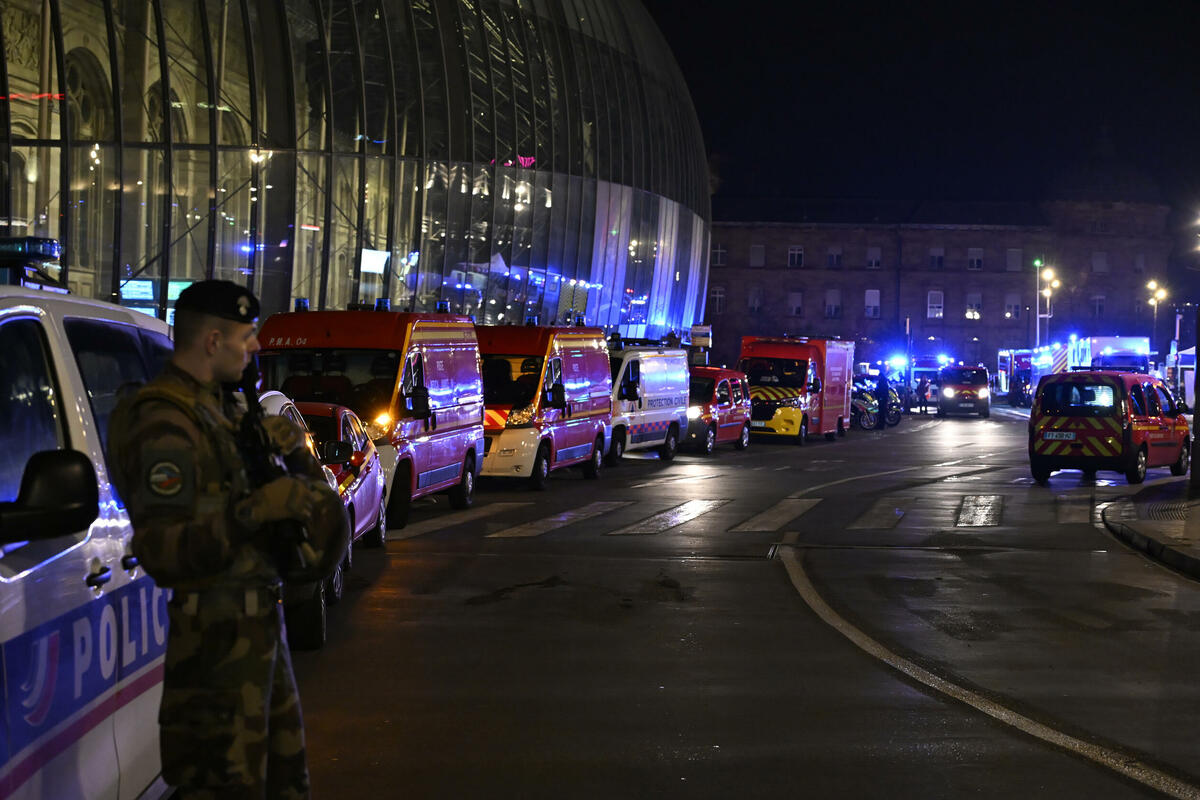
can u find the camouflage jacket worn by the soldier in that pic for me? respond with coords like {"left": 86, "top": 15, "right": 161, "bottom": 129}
{"left": 108, "top": 363, "right": 324, "bottom": 590}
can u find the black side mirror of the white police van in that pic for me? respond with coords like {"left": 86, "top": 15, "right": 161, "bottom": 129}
{"left": 0, "top": 450, "right": 100, "bottom": 545}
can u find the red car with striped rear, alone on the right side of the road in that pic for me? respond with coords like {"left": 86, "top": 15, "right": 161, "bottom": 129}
{"left": 1030, "top": 371, "right": 1192, "bottom": 483}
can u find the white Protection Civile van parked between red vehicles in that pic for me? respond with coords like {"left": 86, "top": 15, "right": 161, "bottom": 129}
{"left": 608, "top": 342, "right": 690, "bottom": 463}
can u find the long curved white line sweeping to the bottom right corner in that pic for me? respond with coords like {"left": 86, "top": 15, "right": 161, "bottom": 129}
{"left": 780, "top": 533, "right": 1200, "bottom": 800}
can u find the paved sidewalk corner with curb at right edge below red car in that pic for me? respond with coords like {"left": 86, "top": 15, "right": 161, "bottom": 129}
{"left": 1102, "top": 479, "right": 1200, "bottom": 581}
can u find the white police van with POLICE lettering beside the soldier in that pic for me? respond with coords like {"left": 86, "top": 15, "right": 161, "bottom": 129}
{"left": 0, "top": 287, "right": 172, "bottom": 800}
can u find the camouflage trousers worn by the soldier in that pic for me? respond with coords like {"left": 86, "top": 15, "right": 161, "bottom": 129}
{"left": 158, "top": 590, "right": 308, "bottom": 800}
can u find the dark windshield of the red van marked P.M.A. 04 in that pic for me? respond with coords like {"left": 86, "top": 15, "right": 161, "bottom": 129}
{"left": 258, "top": 349, "right": 402, "bottom": 420}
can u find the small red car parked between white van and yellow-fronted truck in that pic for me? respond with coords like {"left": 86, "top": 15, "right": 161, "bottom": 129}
{"left": 688, "top": 366, "right": 750, "bottom": 455}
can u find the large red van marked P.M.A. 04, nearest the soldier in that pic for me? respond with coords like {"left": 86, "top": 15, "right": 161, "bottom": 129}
{"left": 258, "top": 311, "right": 484, "bottom": 528}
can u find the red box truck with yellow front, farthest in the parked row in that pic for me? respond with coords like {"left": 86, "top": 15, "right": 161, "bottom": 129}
{"left": 738, "top": 336, "right": 854, "bottom": 445}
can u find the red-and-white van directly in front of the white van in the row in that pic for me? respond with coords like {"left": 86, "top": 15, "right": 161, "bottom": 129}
{"left": 475, "top": 325, "right": 612, "bottom": 489}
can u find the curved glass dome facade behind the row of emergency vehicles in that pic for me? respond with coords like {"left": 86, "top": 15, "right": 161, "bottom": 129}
{"left": 0, "top": 0, "right": 710, "bottom": 336}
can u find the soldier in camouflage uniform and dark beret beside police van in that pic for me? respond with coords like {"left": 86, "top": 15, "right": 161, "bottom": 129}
{"left": 109, "top": 281, "right": 346, "bottom": 798}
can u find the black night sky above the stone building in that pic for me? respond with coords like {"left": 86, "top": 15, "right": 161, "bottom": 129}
{"left": 644, "top": 0, "right": 1200, "bottom": 266}
